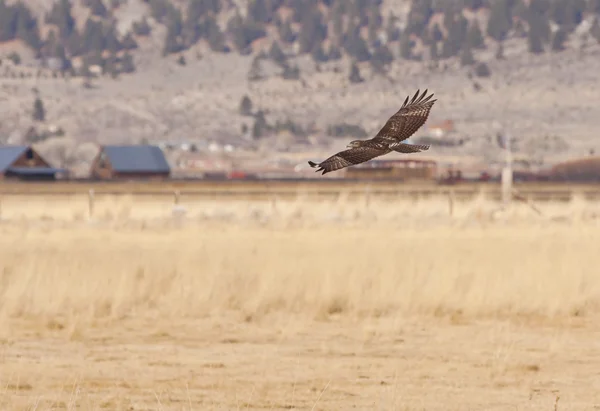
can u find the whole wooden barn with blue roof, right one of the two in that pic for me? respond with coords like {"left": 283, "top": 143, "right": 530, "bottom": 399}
{"left": 90, "top": 145, "right": 171, "bottom": 180}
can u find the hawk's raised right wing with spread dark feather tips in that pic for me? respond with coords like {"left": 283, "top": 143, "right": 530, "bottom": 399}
{"left": 373, "top": 90, "right": 437, "bottom": 148}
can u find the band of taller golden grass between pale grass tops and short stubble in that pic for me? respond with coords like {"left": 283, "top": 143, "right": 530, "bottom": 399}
{"left": 0, "top": 217, "right": 600, "bottom": 322}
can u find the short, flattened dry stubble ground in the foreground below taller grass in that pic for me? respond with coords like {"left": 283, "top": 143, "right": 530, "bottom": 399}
{"left": 0, "top": 316, "right": 600, "bottom": 410}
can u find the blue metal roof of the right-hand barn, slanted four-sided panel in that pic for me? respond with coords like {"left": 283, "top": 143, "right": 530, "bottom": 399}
{"left": 103, "top": 145, "right": 171, "bottom": 173}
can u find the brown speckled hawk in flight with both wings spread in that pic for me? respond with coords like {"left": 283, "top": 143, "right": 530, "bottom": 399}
{"left": 308, "top": 90, "right": 437, "bottom": 174}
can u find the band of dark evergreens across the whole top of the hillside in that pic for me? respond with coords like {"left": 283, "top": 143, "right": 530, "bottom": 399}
{"left": 0, "top": 0, "right": 600, "bottom": 82}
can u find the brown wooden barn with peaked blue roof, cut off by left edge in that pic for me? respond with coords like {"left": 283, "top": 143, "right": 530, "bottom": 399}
{"left": 0, "top": 146, "right": 67, "bottom": 181}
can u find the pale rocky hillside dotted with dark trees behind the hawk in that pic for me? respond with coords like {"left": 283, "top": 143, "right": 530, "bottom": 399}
{"left": 0, "top": 0, "right": 600, "bottom": 173}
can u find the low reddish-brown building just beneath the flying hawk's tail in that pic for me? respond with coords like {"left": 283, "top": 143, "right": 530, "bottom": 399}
{"left": 344, "top": 159, "right": 437, "bottom": 180}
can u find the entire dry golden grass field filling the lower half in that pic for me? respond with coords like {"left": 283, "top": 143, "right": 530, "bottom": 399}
{"left": 0, "top": 188, "right": 600, "bottom": 411}
